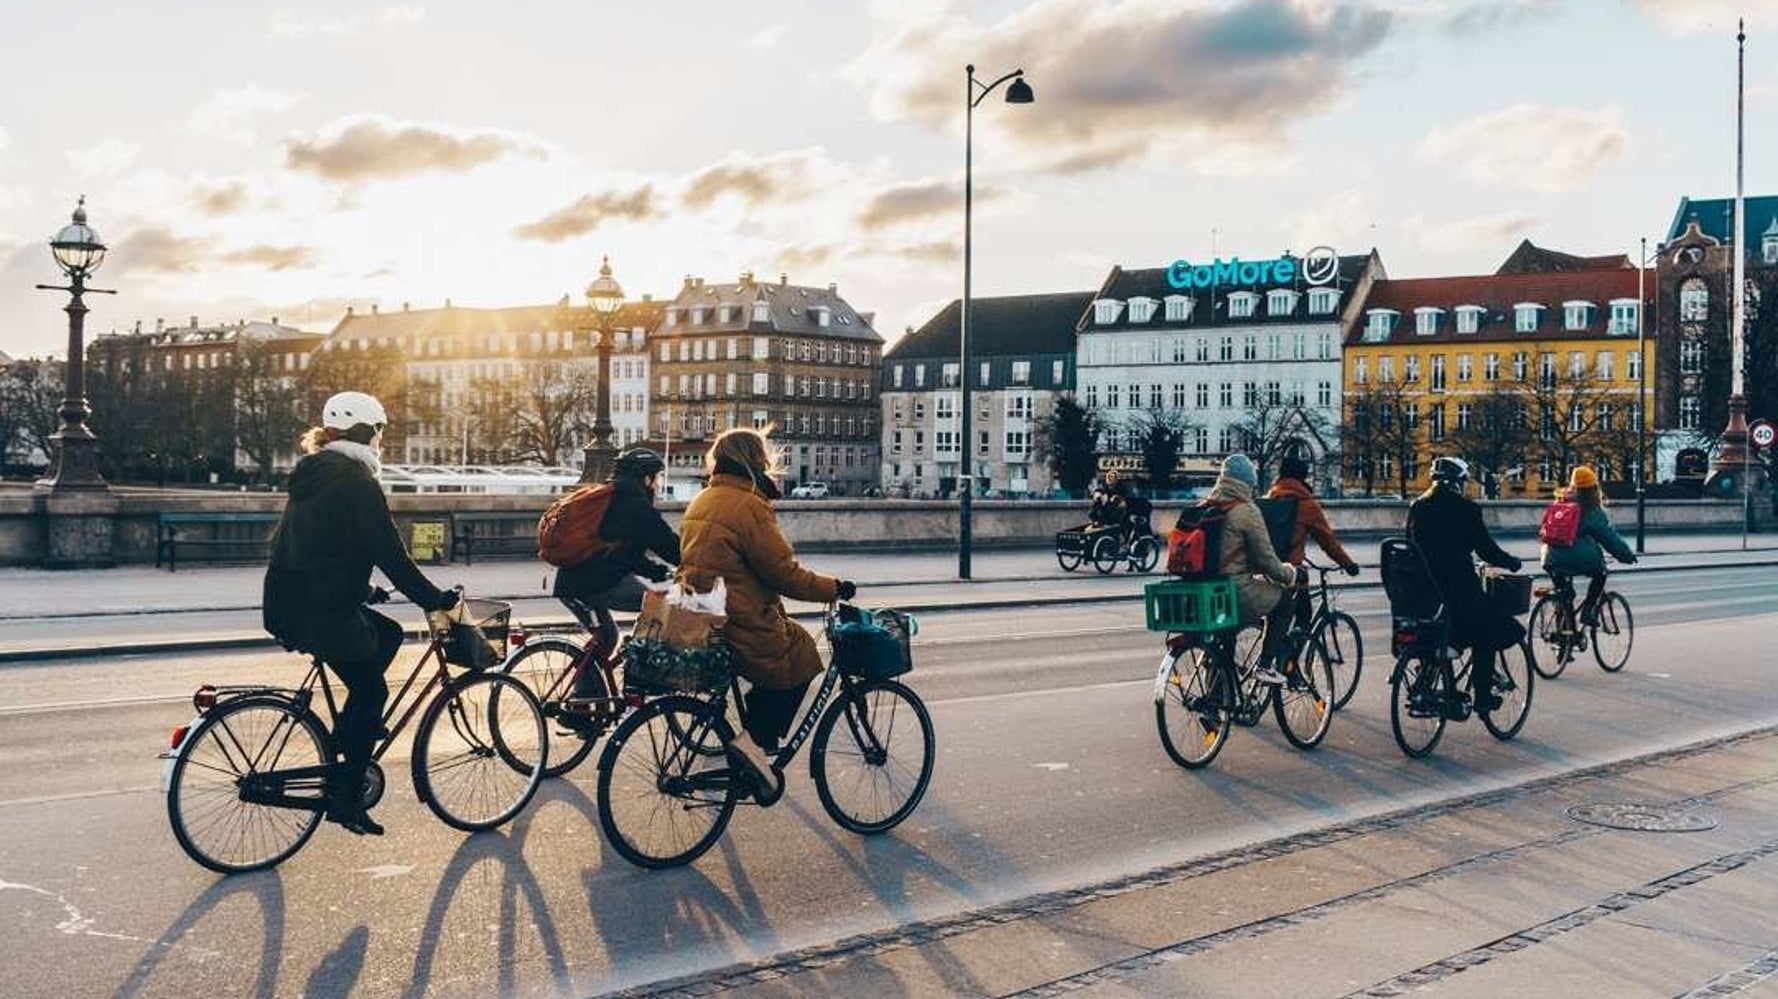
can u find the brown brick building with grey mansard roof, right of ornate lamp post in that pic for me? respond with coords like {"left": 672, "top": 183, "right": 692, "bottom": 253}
{"left": 649, "top": 272, "right": 882, "bottom": 496}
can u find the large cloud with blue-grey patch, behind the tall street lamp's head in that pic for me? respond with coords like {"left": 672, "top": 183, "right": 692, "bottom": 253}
{"left": 845, "top": 0, "right": 1396, "bottom": 172}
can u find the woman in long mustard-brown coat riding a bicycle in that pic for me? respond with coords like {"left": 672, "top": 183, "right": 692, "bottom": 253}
{"left": 679, "top": 428, "right": 857, "bottom": 802}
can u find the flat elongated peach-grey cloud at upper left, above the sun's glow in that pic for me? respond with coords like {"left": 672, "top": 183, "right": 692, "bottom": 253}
{"left": 284, "top": 117, "right": 544, "bottom": 183}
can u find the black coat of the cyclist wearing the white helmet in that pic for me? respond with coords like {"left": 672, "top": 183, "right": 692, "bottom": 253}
{"left": 261, "top": 450, "right": 450, "bottom": 663}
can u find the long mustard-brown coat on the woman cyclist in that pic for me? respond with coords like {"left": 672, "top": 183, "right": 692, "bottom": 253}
{"left": 679, "top": 473, "right": 839, "bottom": 690}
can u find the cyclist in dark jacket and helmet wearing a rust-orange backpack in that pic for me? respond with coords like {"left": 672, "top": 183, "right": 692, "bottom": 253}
{"left": 537, "top": 448, "right": 679, "bottom": 731}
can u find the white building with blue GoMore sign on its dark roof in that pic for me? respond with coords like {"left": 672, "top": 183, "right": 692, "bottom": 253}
{"left": 1076, "top": 251, "right": 1385, "bottom": 487}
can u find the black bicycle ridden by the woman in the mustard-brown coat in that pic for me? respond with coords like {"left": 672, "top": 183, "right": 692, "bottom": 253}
{"left": 599, "top": 604, "right": 935, "bottom": 867}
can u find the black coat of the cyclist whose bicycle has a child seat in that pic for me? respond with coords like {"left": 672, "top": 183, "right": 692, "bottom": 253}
{"left": 1408, "top": 485, "right": 1526, "bottom": 651}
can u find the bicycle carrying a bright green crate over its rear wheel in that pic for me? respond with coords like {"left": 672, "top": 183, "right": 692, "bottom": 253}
{"left": 1150, "top": 572, "right": 1334, "bottom": 770}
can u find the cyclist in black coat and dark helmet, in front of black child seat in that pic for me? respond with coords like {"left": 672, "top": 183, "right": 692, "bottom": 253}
{"left": 1408, "top": 457, "right": 1526, "bottom": 718}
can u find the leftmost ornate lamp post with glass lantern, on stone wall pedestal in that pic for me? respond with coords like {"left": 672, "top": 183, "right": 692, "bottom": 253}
{"left": 37, "top": 197, "right": 116, "bottom": 491}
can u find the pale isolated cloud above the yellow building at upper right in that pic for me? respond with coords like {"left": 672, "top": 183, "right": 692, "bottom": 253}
{"left": 1421, "top": 103, "right": 1630, "bottom": 194}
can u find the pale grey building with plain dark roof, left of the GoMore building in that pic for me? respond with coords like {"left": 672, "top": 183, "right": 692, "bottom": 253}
{"left": 882, "top": 292, "right": 1093, "bottom": 496}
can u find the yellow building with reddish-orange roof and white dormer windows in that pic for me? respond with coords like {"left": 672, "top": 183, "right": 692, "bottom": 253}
{"left": 1341, "top": 252, "right": 1655, "bottom": 498}
